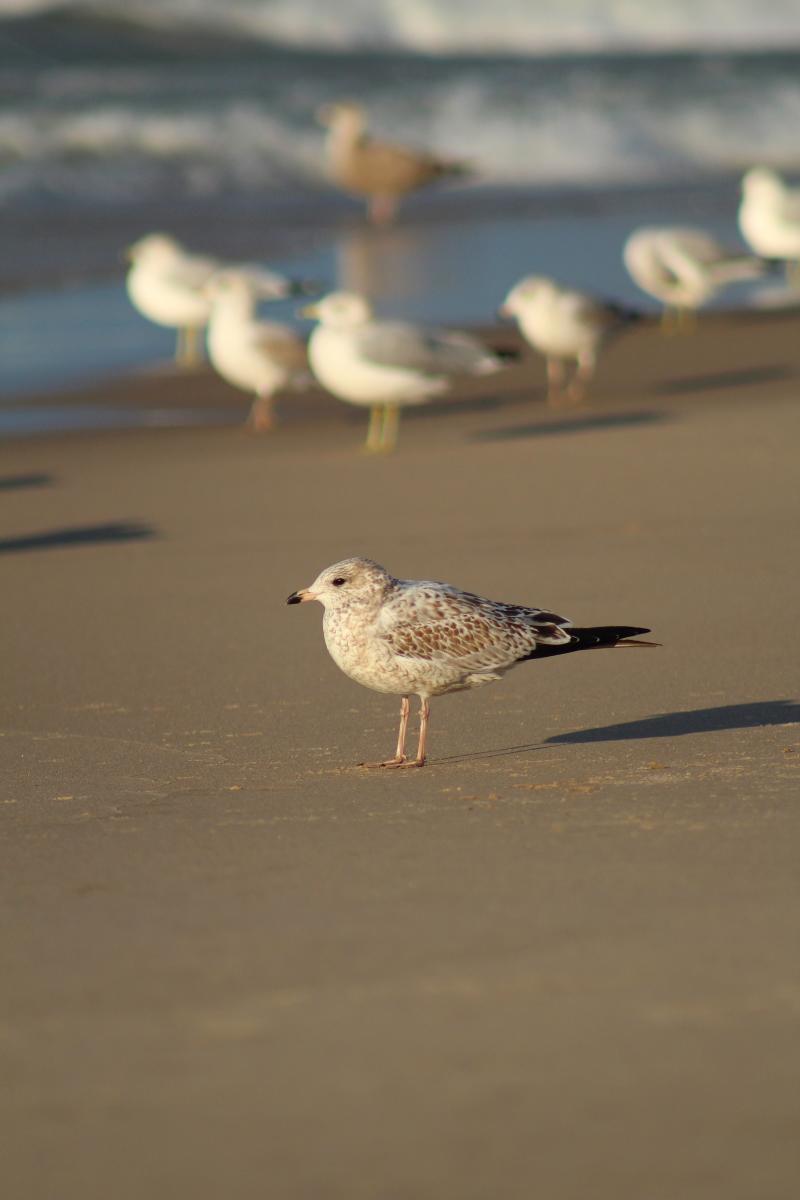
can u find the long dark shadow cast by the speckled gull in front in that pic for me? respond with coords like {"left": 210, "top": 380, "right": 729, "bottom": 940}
{"left": 432, "top": 700, "right": 800, "bottom": 766}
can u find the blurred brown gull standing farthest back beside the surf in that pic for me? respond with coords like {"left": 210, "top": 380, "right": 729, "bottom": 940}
{"left": 317, "top": 101, "right": 470, "bottom": 224}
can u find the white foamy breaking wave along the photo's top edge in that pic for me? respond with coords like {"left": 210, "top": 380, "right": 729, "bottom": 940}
{"left": 0, "top": 0, "right": 800, "bottom": 56}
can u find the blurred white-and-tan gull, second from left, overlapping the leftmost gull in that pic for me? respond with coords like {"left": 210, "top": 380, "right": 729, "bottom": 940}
{"left": 204, "top": 268, "right": 307, "bottom": 433}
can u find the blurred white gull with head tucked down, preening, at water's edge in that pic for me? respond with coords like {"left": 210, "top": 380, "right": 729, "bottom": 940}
{"left": 622, "top": 226, "right": 768, "bottom": 331}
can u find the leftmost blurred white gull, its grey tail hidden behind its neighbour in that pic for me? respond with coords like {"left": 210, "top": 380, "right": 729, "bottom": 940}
{"left": 125, "top": 233, "right": 224, "bottom": 366}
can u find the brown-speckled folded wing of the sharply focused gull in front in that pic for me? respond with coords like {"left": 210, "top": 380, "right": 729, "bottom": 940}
{"left": 381, "top": 586, "right": 570, "bottom": 671}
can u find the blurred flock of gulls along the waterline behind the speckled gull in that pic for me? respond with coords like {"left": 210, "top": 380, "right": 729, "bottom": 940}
{"left": 127, "top": 102, "right": 800, "bottom": 452}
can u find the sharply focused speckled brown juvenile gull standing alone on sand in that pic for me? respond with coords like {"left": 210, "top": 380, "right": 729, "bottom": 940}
{"left": 287, "top": 558, "right": 657, "bottom": 767}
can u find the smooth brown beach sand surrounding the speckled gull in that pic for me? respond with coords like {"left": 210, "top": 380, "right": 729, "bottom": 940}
{"left": 0, "top": 317, "right": 800, "bottom": 1200}
